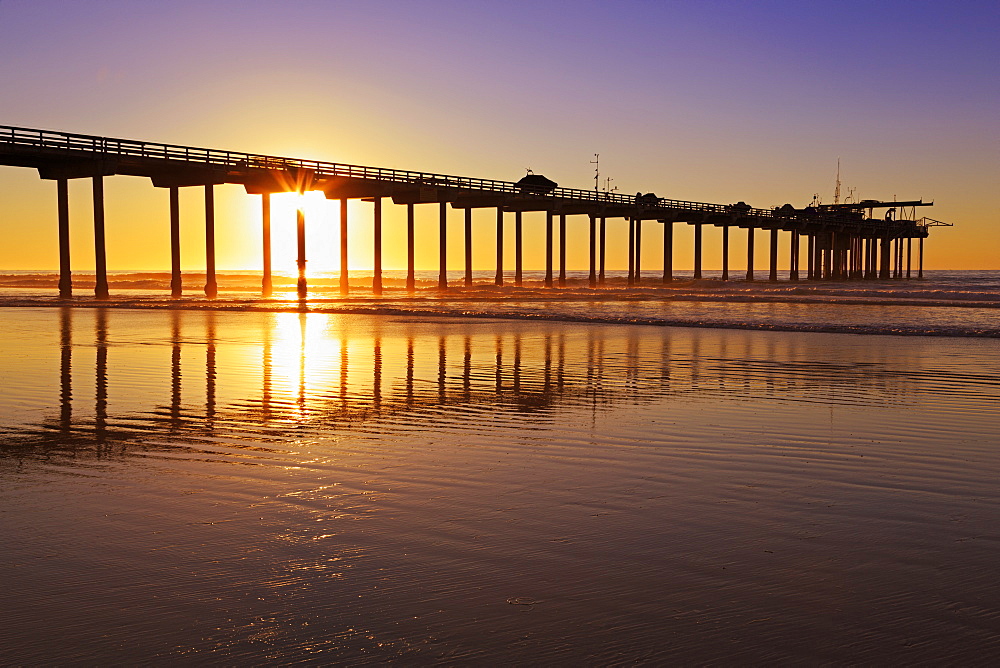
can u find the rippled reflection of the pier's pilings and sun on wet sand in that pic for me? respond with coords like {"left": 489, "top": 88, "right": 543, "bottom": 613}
{"left": 8, "top": 307, "right": 924, "bottom": 460}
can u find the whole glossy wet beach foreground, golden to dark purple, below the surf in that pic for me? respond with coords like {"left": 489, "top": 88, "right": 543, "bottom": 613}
{"left": 0, "top": 306, "right": 1000, "bottom": 665}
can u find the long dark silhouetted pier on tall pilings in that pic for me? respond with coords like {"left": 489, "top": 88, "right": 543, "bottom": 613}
{"left": 0, "top": 125, "right": 948, "bottom": 299}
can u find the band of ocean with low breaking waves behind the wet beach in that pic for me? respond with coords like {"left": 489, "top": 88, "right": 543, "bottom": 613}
{"left": 0, "top": 271, "right": 1000, "bottom": 338}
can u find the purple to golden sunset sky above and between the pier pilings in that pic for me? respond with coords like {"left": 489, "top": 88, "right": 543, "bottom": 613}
{"left": 0, "top": 0, "right": 1000, "bottom": 271}
